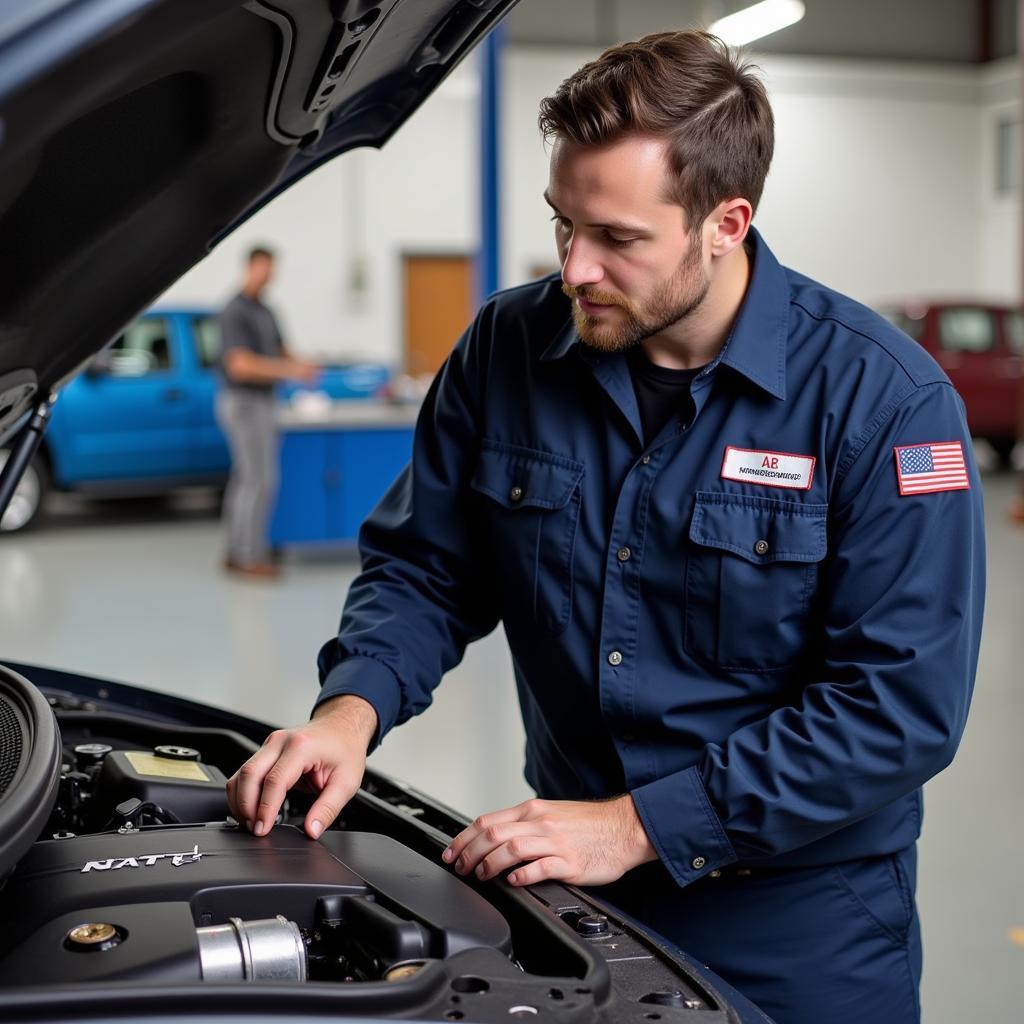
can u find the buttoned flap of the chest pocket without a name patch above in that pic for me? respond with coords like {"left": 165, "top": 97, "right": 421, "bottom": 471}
{"left": 470, "top": 441, "right": 584, "bottom": 509}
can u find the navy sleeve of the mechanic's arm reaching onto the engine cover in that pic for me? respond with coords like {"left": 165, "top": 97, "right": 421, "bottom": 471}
{"left": 316, "top": 306, "right": 498, "bottom": 748}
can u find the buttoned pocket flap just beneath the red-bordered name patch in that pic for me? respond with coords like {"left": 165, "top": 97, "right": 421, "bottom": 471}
{"left": 690, "top": 490, "right": 828, "bottom": 565}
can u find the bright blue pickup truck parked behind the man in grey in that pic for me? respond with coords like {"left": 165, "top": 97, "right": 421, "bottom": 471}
{"left": 0, "top": 307, "right": 390, "bottom": 532}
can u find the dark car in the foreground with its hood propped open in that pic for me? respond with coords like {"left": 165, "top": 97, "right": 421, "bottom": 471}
{"left": 0, "top": 0, "right": 766, "bottom": 1024}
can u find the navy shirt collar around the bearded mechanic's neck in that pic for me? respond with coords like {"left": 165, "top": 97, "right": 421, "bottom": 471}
{"left": 541, "top": 227, "right": 790, "bottom": 399}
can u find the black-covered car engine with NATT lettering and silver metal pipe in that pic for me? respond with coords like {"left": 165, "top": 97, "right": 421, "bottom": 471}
{"left": 0, "top": 743, "right": 511, "bottom": 986}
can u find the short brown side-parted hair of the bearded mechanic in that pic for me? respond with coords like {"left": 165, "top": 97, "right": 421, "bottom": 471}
{"left": 540, "top": 32, "right": 775, "bottom": 229}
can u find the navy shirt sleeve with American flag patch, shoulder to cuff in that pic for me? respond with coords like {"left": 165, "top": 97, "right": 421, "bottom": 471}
{"left": 633, "top": 383, "right": 985, "bottom": 885}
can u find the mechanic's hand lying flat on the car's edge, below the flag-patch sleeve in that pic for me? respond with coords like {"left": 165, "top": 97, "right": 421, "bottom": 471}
{"left": 441, "top": 794, "right": 657, "bottom": 886}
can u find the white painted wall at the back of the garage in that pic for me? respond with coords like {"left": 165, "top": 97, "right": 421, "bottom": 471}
{"left": 167, "top": 47, "right": 1021, "bottom": 367}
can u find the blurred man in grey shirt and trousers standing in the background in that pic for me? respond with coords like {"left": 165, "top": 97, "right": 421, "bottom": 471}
{"left": 217, "top": 248, "right": 319, "bottom": 579}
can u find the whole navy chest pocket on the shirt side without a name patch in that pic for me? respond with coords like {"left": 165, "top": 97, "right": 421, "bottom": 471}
{"left": 470, "top": 441, "right": 584, "bottom": 634}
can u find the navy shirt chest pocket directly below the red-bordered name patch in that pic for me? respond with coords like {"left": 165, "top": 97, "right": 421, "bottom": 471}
{"left": 684, "top": 492, "right": 828, "bottom": 672}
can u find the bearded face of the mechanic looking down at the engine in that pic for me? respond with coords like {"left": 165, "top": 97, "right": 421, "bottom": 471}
{"left": 545, "top": 136, "right": 710, "bottom": 352}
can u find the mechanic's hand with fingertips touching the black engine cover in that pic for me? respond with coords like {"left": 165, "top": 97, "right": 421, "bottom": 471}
{"left": 227, "top": 694, "right": 377, "bottom": 839}
